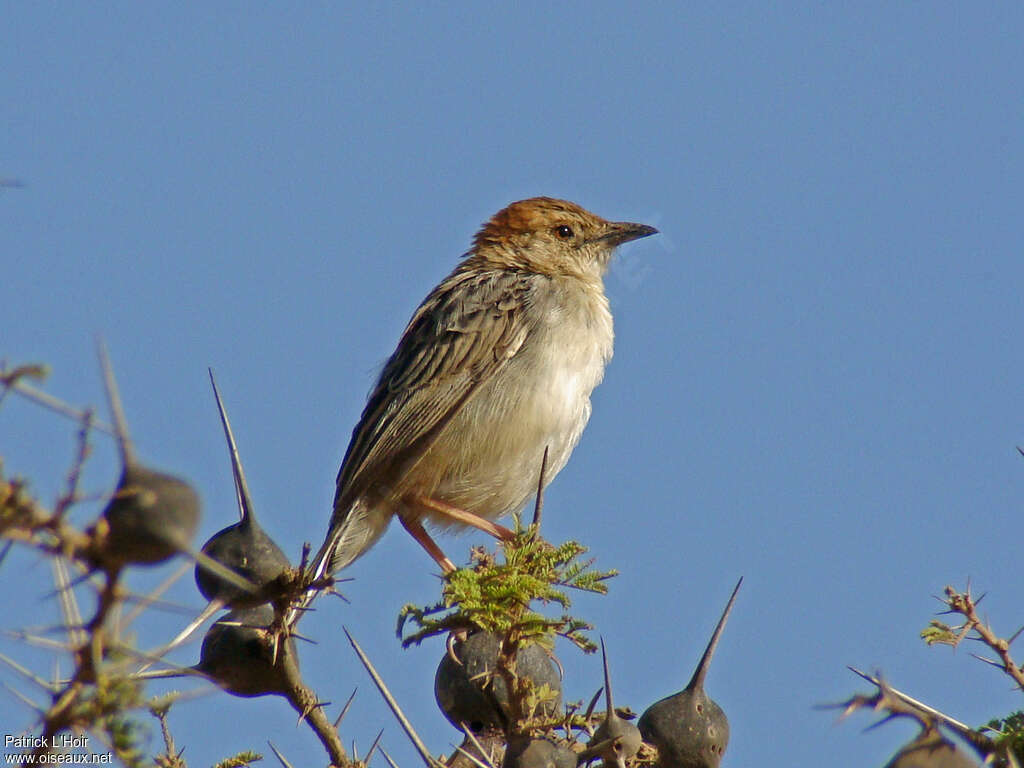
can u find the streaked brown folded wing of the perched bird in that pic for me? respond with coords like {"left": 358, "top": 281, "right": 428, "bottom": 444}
{"left": 334, "top": 270, "right": 538, "bottom": 518}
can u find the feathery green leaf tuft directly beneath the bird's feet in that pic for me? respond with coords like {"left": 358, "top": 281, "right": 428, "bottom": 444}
{"left": 397, "top": 518, "right": 617, "bottom": 652}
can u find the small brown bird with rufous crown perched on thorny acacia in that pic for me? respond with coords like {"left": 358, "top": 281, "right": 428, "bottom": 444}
{"left": 314, "top": 198, "right": 657, "bottom": 577}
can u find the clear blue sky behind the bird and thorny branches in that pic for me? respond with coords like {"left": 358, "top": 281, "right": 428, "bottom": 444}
{"left": 0, "top": 2, "right": 1024, "bottom": 767}
